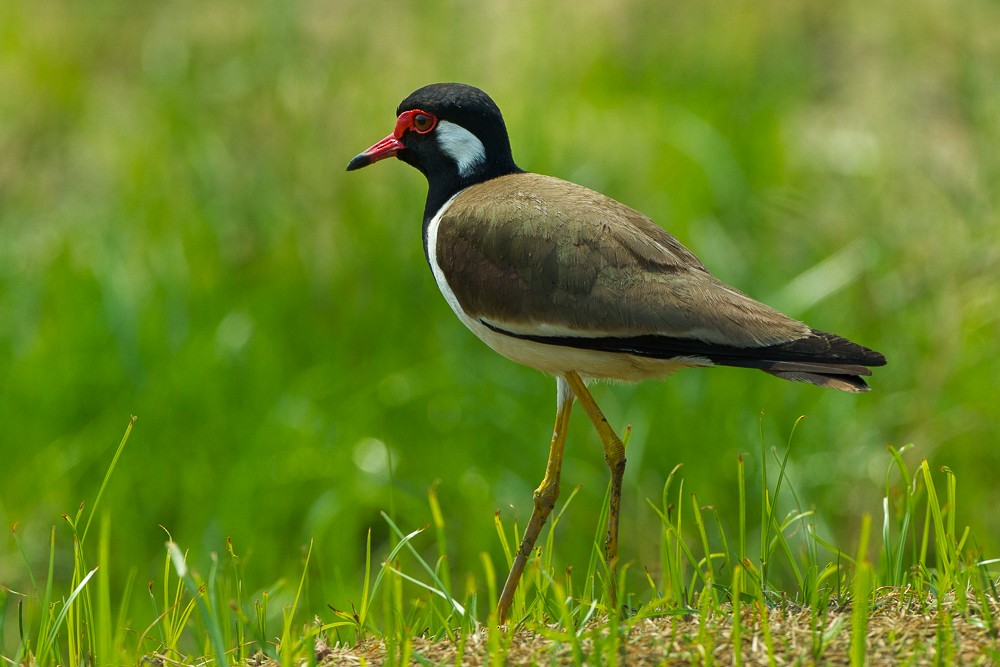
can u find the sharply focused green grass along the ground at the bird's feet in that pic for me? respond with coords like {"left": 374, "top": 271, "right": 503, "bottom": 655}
{"left": 0, "top": 424, "right": 1000, "bottom": 667}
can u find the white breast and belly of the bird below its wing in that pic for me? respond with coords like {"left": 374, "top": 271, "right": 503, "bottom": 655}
{"left": 427, "top": 192, "right": 713, "bottom": 382}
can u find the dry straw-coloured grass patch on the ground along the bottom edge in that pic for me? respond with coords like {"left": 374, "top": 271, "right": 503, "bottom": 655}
{"left": 312, "top": 590, "right": 1000, "bottom": 665}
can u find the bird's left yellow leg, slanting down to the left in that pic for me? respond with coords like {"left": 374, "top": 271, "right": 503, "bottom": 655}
{"left": 497, "top": 378, "right": 574, "bottom": 624}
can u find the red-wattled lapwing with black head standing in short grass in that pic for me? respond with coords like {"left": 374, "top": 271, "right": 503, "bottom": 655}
{"left": 347, "top": 83, "right": 885, "bottom": 623}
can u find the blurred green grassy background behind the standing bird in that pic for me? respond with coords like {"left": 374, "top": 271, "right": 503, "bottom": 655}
{"left": 0, "top": 0, "right": 1000, "bottom": 628}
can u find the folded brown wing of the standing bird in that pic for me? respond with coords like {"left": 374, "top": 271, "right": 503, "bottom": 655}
{"left": 436, "top": 174, "right": 810, "bottom": 347}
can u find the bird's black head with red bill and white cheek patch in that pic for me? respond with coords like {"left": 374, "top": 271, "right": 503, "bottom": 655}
{"left": 347, "top": 83, "right": 521, "bottom": 217}
